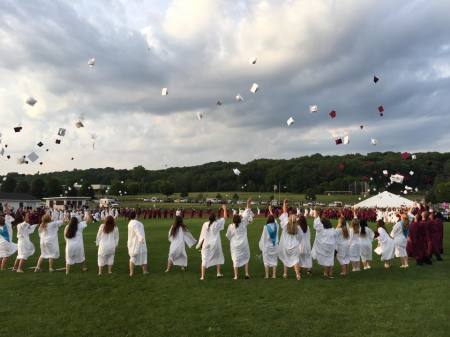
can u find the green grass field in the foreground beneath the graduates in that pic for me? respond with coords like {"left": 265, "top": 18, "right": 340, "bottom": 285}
{"left": 0, "top": 219, "right": 450, "bottom": 337}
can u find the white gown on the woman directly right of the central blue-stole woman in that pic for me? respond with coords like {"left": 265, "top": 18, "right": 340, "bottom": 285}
{"left": 278, "top": 213, "right": 301, "bottom": 268}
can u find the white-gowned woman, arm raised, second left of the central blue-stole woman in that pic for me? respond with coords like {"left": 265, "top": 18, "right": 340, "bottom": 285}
{"left": 196, "top": 205, "right": 227, "bottom": 281}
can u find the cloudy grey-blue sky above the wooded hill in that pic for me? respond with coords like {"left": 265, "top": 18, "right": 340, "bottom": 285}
{"left": 0, "top": 0, "right": 450, "bottom": 174}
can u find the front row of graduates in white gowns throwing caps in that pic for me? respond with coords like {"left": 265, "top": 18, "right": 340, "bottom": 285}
{"left": 0, "top": 200, "right": 442, "bottom": 280}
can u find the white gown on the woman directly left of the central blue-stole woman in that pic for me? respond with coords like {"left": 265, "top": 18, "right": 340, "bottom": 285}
{"left": 226, "top": 208, "right": 253, "bottom": 268}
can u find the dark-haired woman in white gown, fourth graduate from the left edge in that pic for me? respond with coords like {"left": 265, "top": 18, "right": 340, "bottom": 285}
{"left": 64, "top": 216, "right": 90, "bottom": 275}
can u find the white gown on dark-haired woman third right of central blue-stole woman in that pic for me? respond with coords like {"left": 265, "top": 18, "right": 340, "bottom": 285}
{"left": 311, "top": 217, "right": 336, "bottom": 267}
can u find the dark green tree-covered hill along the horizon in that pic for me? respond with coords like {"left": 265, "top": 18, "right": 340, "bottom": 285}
{"left": 0, "top": 152, "right": 450, "bottom": 201}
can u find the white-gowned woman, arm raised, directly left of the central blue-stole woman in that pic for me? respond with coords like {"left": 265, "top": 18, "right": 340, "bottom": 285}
{"left": 226, "top": 199, "right": 254, "bottom": 280}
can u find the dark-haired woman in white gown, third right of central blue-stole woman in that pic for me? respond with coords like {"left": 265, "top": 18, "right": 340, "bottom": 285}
{"left": 311, "top": 210, "right": 336, "bottom": 278}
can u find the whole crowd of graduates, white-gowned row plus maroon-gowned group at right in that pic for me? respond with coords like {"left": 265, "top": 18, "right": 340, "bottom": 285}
{"left": 0, "top": 200, "right": 444, "bottom": 280}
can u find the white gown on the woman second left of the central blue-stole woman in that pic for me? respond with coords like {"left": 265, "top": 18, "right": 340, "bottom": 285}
{"left": 197, "top": 218, "right": 225, "bottom": 268}
